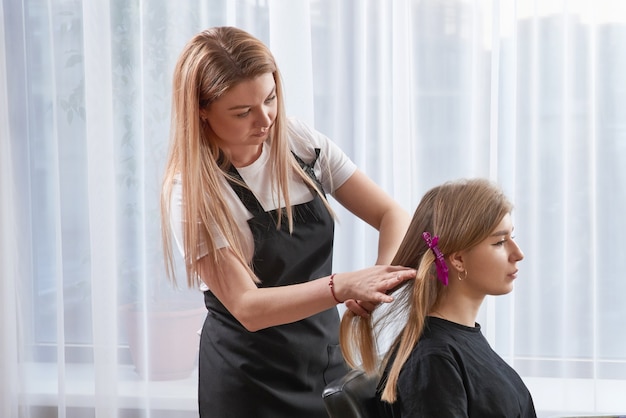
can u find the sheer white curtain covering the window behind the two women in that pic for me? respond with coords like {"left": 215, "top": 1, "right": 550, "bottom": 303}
{"left": 0, "top": 0, "right": 626, "bottom": 417}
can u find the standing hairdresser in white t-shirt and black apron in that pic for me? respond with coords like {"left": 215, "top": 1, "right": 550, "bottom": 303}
{"left": 162, "top": 27, "right": 415, "bottom": 418}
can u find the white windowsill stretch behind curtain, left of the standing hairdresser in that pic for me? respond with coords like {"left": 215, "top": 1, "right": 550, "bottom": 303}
{"left": 20, "top": 363, "right": 198, "bottom": 411}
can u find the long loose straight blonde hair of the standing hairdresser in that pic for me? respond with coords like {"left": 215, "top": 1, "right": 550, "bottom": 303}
{"left": 161, "top": 27, "right": 332, "bottom": 287}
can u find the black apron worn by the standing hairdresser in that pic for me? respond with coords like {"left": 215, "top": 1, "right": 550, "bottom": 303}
{"left": 198, "top": 149, "right": 347, "bottom": 418}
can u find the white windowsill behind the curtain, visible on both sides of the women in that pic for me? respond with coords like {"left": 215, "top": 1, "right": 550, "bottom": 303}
{"left": 20, "top": 363, "right": 626, "bottom": 417}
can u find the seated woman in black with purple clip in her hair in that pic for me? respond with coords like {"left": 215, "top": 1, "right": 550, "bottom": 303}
{"left": 340, "top": 179, "right": 536, "bottom": 418}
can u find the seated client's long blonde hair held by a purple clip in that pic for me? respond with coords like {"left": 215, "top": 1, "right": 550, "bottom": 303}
{"left": 340, "top": 179, "right": 512, "bottom": 403}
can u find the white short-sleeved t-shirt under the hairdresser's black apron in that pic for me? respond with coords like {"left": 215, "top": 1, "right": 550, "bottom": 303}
{"left": 170, "top": 119, "right": 356, "bottom": 272}
